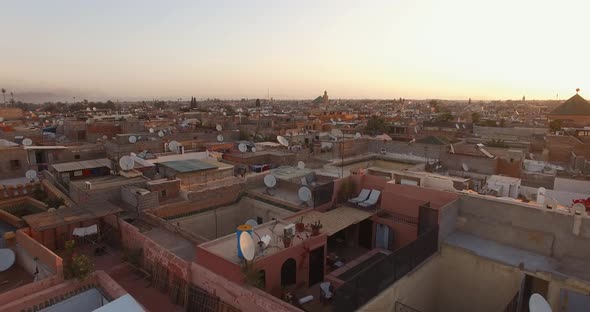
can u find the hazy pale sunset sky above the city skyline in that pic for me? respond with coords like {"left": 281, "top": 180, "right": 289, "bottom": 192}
{"left": 0, "top": 0, "right": 590, "bottom": 100}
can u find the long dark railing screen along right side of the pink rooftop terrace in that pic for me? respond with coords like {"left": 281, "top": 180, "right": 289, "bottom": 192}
{"left": 334, "top": 226, "right": 438, "bottom": 311}
